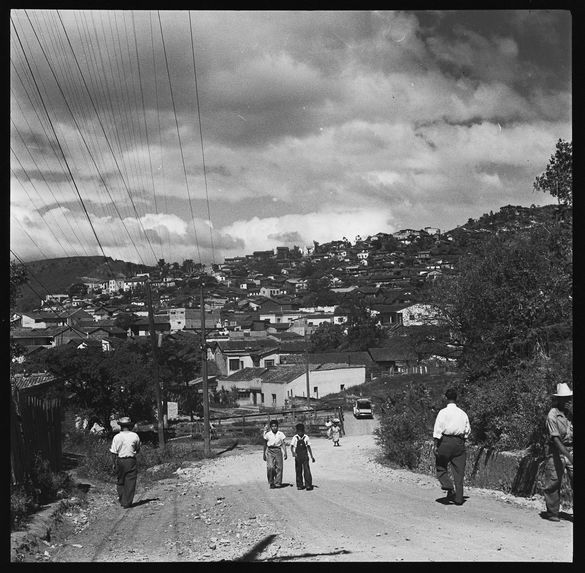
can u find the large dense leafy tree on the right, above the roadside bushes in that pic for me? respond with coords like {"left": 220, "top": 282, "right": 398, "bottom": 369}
{"left": 430, "top": 222, "right": 572, "bottom": 377}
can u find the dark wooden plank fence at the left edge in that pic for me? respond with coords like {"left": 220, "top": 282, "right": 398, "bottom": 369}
{"left": 10, "top": 392, "right": 62, "bottom": 484}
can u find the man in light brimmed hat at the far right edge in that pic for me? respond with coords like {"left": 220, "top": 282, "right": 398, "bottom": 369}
{"left": 543, "top": 382, "right": 573, "bottom": 521}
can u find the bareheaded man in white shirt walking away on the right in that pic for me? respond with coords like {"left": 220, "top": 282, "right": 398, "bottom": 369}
{"left": 433, "top": 388, "right": 471, "bottom": 505}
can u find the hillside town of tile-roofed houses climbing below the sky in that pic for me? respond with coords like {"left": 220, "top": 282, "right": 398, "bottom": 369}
{"left": 12, "top": 206, "right": 547, "bottom": 409}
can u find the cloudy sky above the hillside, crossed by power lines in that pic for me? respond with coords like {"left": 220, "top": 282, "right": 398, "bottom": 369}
{"left": 10, "top": 10, "right": 572, "bottom": 264}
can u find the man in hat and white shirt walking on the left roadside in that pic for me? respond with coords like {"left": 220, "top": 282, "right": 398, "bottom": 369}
{"left": 110, "top": 416, "right": 140, "bottom": 508}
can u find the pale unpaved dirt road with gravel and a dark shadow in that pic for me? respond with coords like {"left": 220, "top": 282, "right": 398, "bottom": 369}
{"left": 44, "top": 416, "right": 573, "bottom": 562}
